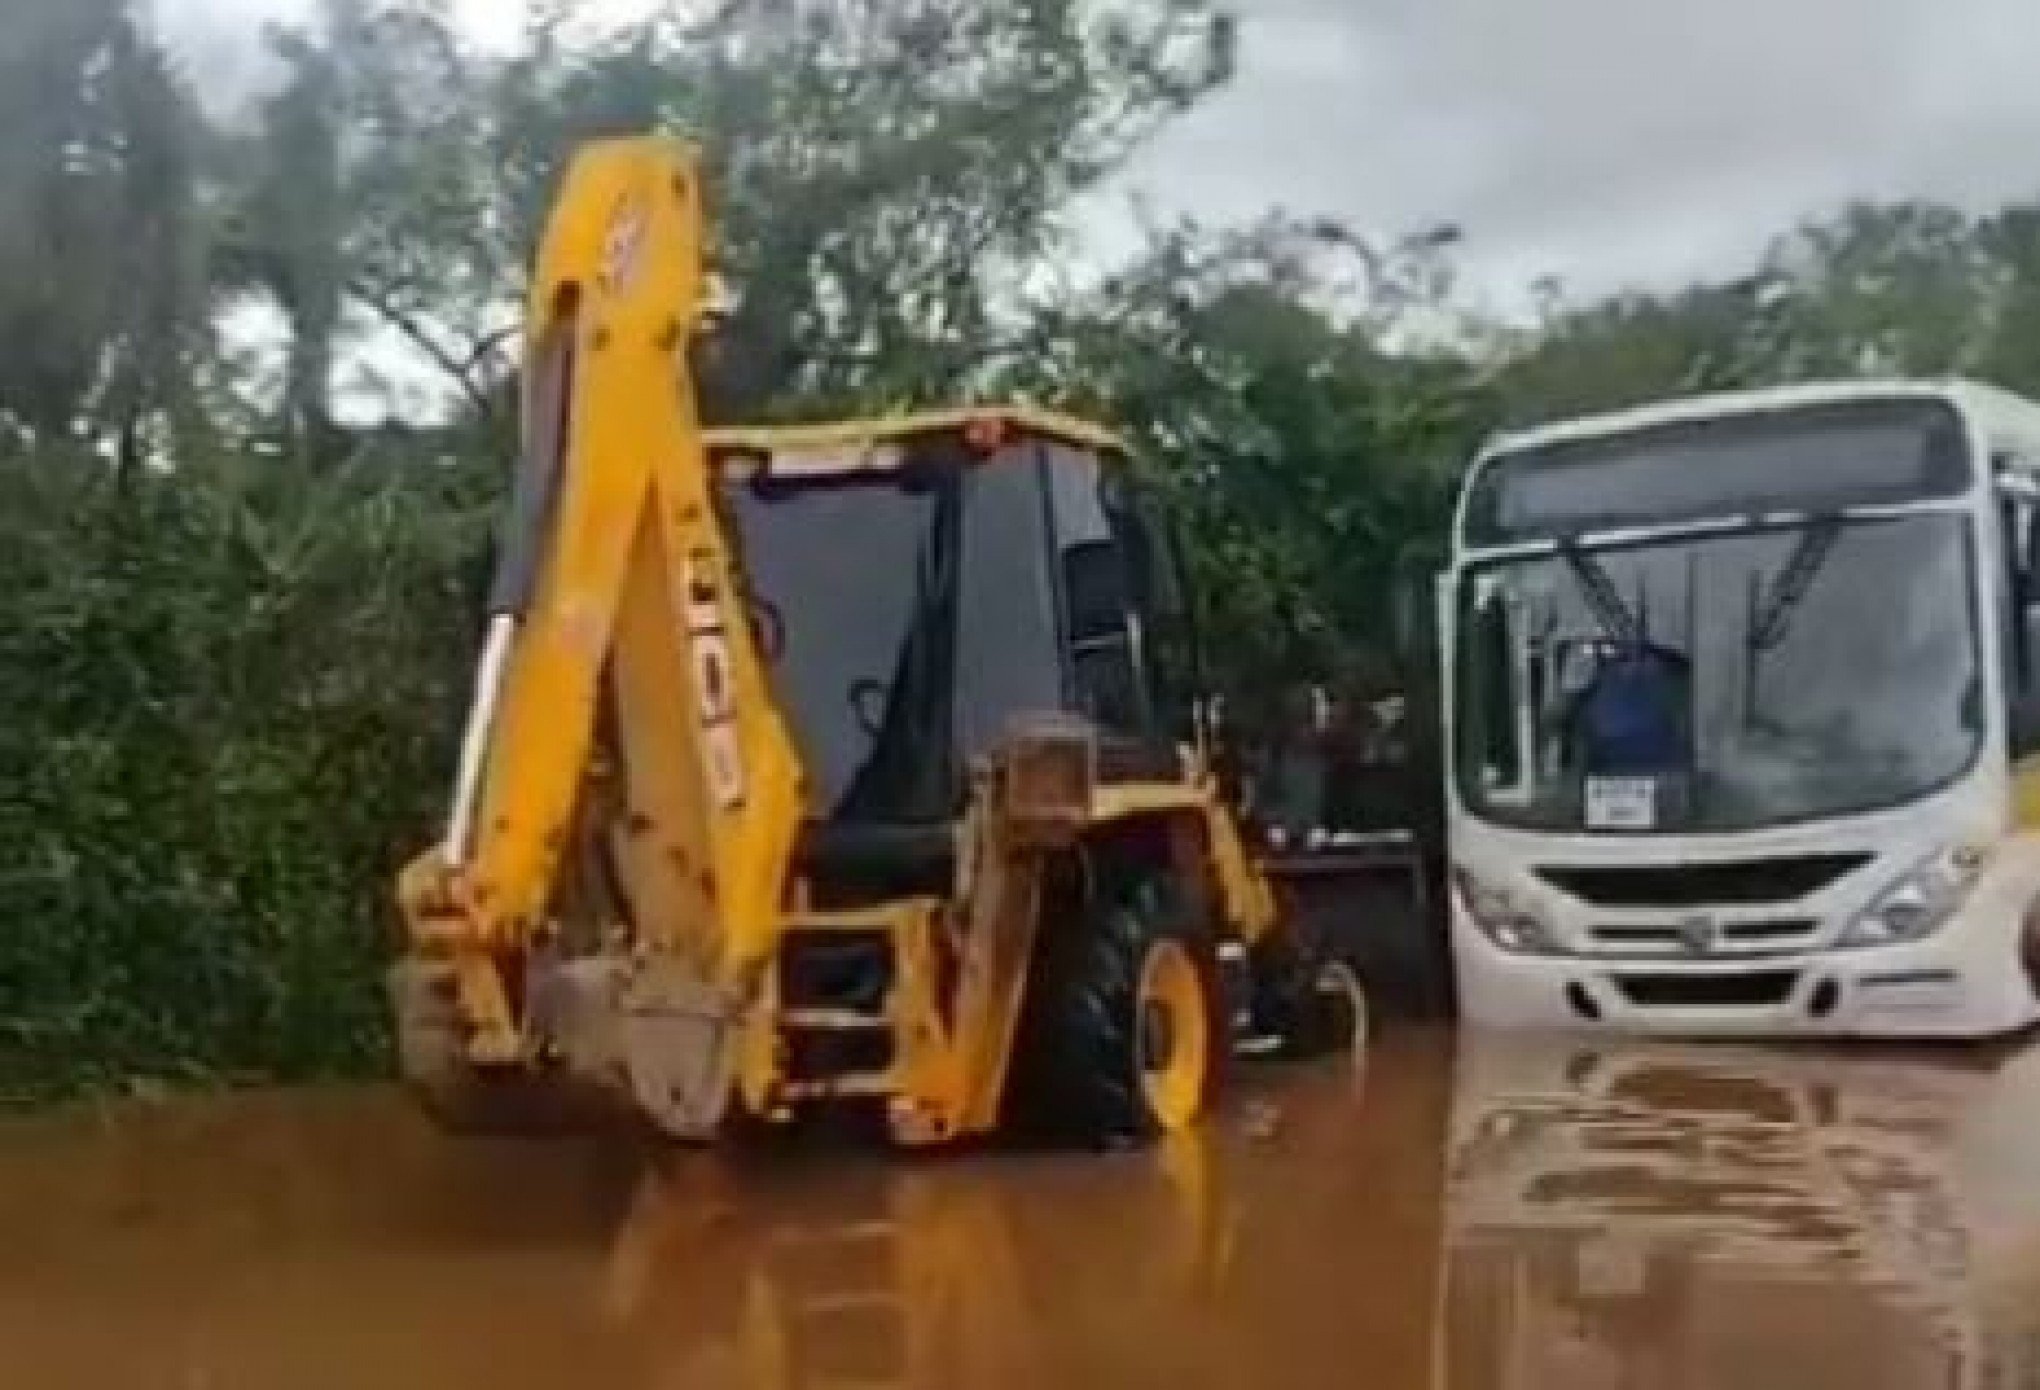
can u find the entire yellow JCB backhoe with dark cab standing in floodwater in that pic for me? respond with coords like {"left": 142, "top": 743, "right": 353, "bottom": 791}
{"left": 392, "top": 141, "right": 1361, "bottom": 1143}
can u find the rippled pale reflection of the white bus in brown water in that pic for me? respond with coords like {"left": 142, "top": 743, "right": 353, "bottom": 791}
{"left": 1444, "top": 1037, "right": 2040, "bottom": 1390}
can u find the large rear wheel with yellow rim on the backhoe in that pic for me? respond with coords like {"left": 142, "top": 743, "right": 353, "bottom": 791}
{"left": 1014, "top": 876, "right": 1226, "bottom": 1143}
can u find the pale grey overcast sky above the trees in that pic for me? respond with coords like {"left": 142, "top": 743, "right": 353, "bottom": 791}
{"left": 155, "top": 0, "right": 2040, "bottom": 302}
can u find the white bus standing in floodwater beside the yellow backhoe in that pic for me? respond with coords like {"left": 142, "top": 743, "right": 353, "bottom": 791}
{"left": 1440, "top": 382, "right": 2040, "bottom": 1037}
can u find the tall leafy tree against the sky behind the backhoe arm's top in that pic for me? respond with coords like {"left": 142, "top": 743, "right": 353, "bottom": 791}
{"left": 318, "top": 0, "right": 1232, "bottom": 418}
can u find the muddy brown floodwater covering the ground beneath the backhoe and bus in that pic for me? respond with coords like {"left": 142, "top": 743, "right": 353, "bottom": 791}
{"left": 0, "top": 1035, "right": 2040, "bottom": 1390}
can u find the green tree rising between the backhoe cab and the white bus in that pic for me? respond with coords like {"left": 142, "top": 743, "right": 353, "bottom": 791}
{"left": 1018, "top": 222, "right": 1491, "bottom": 710}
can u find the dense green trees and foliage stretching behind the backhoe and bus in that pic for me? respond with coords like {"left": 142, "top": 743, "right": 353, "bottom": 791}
{"left": 0, "top": 0, "right": 2040, "bottom": 1096}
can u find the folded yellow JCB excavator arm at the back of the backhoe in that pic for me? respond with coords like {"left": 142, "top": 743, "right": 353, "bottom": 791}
{"left": 400, "top": 139, "right": 802, "bottom": 1114}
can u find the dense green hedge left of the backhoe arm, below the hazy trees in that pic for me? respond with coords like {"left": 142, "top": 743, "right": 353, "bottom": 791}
{"left": 0, "top": 432, "right": 488, "bottom": 1094}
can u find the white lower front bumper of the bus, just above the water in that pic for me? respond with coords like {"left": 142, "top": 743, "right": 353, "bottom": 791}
{"left": 1452, "top": 914, "right": 2040, "bottom": 1037}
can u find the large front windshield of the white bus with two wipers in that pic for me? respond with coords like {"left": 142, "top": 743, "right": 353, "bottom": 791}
{"left": 1455, "top": 510, "right": 1985, "bottom": 833}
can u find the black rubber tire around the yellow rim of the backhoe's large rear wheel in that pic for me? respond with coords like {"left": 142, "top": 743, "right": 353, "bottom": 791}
{"left": 1008, "top": 874, "right": 1228, "bottom": 1145}
